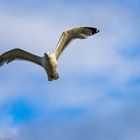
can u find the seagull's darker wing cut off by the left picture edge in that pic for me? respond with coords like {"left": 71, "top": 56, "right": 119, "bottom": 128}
{"left": 0, "top": 49, "right": 42, "bottom": 66}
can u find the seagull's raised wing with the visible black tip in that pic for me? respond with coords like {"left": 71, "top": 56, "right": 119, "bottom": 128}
{"left": 54, "top": 27, "right": 99, "bottom": 59}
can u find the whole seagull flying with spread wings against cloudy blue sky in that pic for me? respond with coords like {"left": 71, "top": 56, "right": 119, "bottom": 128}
{"left": 0, "top": 27, "right": 99, "bottom": 81}
